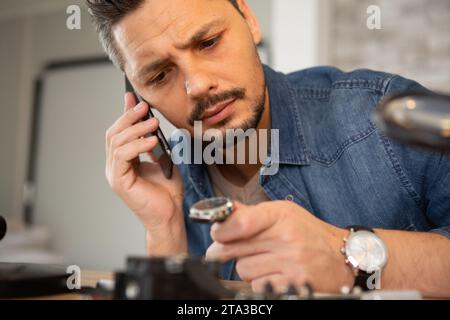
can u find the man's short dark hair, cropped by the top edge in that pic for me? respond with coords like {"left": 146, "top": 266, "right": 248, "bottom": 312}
{"left": 86, "top": 0, "right": 242, "bottom": 70}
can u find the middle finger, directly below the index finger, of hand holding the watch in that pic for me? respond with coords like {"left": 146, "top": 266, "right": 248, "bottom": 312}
{"left": 206, "top": 239, "right": 274, "bottom": 262}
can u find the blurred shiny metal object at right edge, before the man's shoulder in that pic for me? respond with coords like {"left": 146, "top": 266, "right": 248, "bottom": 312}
{"left": 374, "top": 93, "right": 450, "bottom": 152}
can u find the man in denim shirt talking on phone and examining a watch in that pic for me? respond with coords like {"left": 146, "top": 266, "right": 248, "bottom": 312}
{"left": 88, "top": 0, "right": 450, "bottom": 297}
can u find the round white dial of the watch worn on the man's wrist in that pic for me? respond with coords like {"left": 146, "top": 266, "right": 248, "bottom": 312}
{"left": 345, "top": 231, "right": 387, "bottom": 272}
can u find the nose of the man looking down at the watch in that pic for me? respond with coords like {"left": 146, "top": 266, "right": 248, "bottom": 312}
{"left": 184, "top": 66, "right": 217, "bottom": 99}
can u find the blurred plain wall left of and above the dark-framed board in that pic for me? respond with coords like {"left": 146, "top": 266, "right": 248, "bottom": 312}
{"left": 0, "top": 0, "right": 102, "bottom": 225}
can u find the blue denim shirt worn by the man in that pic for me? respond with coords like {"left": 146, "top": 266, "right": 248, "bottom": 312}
{"left": 171, "top": 66, "right": 450, "bottom": 279}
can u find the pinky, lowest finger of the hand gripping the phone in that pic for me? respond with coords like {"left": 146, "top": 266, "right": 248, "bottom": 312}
{"left": 112, "top": 137, "right": 158, "bottom": 179}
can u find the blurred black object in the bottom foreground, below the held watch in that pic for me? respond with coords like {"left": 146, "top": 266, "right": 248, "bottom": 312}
{"left": 113, "top": 257, "right": 236, "bottom": 300}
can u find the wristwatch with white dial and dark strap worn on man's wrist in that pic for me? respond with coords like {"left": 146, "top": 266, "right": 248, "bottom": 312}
{"left": 341, "top": 226, "right": 388, "bottom": 290}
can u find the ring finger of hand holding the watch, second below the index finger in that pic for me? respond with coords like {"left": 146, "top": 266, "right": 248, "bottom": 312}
{"left": 236, "top": 253, "right": 283, "bottom": 282}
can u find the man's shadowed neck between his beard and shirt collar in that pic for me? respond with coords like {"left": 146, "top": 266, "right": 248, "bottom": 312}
{"left": 217, "top": 88, "right": 270, "bottom": 186}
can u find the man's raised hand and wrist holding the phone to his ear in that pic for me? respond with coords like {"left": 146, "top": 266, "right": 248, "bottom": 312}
{"left": 106, "top": 93, "right": 187, "bottom": 256}
